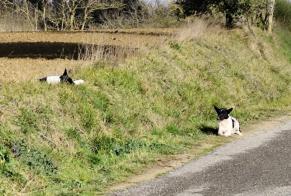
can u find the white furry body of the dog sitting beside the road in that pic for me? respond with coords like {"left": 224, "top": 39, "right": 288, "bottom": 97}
{"left": 218, "top": 116, "right": 242, "bottom": 137}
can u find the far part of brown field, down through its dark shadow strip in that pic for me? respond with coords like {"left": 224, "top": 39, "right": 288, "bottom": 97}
{"left": 0, "top": 29, "right": 174, "bottom": 60}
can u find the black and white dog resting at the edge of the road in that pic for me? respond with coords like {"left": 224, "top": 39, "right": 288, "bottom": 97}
{"left": 214, "top": 106, "right": 242, "bottom": 137}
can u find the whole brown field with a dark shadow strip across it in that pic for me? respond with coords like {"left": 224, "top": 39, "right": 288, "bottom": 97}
{"left": 0, "top": 29, "right": 174, "bottom": 83}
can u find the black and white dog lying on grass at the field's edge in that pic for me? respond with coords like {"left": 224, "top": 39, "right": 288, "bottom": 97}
{"left": 39, "top": 69, "right": 84, "bottom": 85}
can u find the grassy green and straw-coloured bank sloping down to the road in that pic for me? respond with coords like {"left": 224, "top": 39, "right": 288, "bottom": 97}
{"left": 0, "top": 26, "right": 291, "bottom": 194}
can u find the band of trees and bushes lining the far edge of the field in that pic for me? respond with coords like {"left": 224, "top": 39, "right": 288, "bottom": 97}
{"left": 0, "top": 0, "right": 280, "bottom": 31}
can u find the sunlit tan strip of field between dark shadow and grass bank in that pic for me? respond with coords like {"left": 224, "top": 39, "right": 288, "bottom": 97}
{"left": 0, "top": 58, "right": 89, "bottom": 83}
